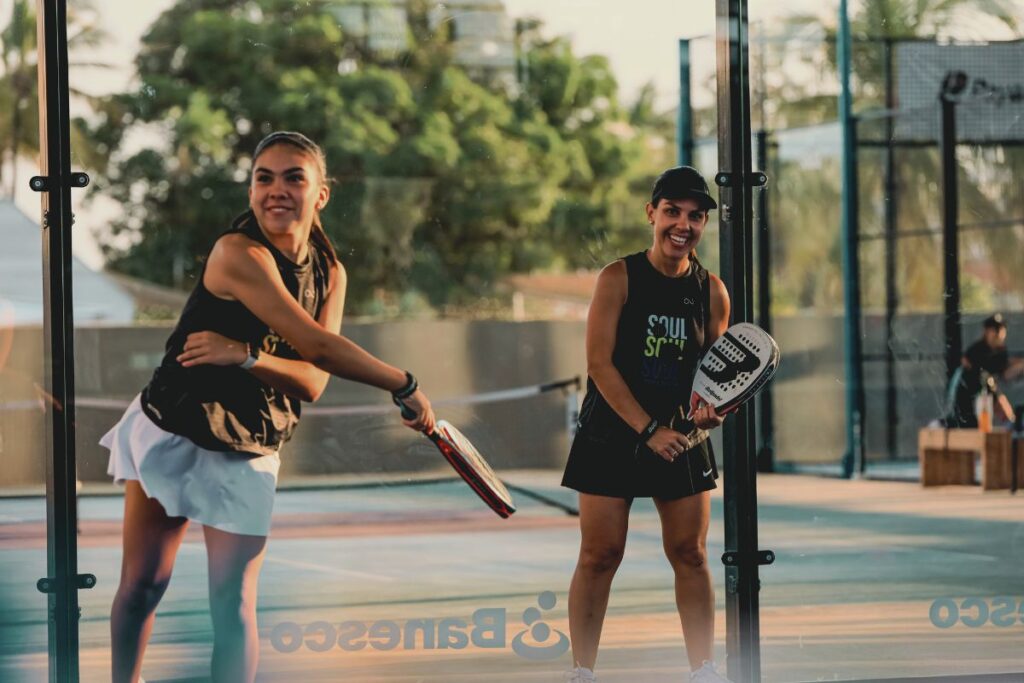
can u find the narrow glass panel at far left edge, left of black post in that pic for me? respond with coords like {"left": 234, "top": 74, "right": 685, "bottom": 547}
{"left": 0, "top": 3, "right": 50, "bottom": 682}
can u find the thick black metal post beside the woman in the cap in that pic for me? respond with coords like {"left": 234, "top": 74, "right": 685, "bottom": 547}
{"left": 715, "top": 0, "right": 773, "bottom": 683}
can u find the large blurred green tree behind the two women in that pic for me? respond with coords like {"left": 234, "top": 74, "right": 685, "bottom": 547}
{"left": 83, "top": 0, "right": 672, "bottom": 314}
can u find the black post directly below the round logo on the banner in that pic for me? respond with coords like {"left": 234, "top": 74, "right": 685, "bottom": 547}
{"left": 940, "top": 94, "right": 963, "bottom": 383}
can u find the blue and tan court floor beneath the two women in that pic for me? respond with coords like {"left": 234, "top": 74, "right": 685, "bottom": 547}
{"left": 0, "top": 471, "right": 1024, "bottom": 683}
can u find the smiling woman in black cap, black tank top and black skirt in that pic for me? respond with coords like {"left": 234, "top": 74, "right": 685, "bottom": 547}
{"left": 562, "top": 167, "right": 729, "bottom": 683}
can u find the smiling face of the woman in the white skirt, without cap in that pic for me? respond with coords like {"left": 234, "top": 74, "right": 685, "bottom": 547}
{"left": 249, "top": 143, "right": 330, "bottom": 236}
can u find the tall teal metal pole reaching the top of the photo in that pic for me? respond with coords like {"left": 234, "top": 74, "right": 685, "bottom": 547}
{"left": 838, "top": 0, "right": 864, "bottom": 478}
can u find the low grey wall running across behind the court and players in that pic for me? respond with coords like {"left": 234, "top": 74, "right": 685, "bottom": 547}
{"left": 6, "top": 313, "right": 1024, "bottom": 495}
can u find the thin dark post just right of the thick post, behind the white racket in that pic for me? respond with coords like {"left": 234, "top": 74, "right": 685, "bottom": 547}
{"left": 754, "top": 129, "right": 775, "bottom": 472}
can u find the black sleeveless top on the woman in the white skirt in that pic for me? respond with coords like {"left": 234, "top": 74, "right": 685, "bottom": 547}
{"left": 142, "top": 212, "right": 331, "bottom": 455}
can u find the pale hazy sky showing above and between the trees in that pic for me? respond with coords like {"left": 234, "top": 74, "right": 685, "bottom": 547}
{"left": 6, "top": 0, "right": 1015, "bottom": 268}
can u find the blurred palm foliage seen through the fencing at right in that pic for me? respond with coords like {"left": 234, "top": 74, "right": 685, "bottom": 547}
{"left": 737, "top": 0, "right": 1024, "bottom": 312}
